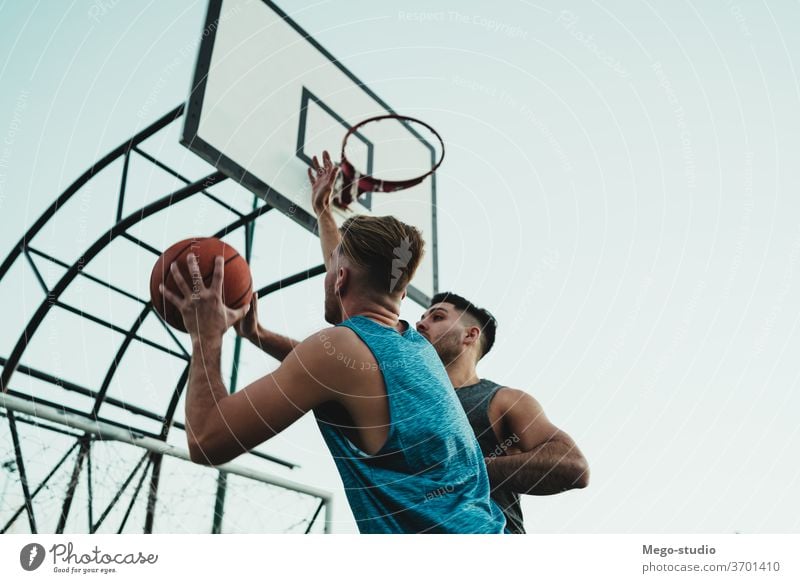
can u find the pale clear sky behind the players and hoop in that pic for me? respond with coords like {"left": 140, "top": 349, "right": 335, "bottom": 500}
{"left": 0, "top": 0, "right": 800, "bottom": 533}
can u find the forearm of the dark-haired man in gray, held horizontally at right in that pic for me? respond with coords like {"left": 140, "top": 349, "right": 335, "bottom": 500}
{"left": 486, "top": 440, "right": 589, "bottom": 496}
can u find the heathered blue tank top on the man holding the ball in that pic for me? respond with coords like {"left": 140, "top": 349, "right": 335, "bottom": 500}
{"left": 314, "top": 316, "right": 505, "bottom": 533}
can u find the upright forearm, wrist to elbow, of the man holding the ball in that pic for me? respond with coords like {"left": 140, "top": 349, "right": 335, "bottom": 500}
{"left": 186, "top": 338, "right": 228, "bottom": 463}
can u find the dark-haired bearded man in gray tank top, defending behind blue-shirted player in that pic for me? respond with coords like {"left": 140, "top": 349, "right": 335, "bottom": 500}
{"left": 417, "top": 293, "right": 589, "bottom": 533}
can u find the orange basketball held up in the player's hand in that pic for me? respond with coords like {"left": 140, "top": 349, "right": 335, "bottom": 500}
{"left": 150, "top": 237, "right": 253, "bottom": 332}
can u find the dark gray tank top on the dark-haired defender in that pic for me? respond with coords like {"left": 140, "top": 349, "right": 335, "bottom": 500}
{"left": 456, "top": 379, "right": 525, "bottom": 534}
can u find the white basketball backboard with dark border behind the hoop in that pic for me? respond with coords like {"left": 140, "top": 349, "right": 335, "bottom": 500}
{"left": 182, "top": 0, "right": 438, "bottom": 307}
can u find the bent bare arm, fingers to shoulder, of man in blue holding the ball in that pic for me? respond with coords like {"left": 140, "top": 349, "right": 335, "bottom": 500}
{"left": 161, "top": 254, "right": 334, "bottom": 465}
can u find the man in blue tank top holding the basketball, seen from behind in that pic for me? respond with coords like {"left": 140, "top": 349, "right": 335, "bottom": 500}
{"left": 160, "top": 166, "right": 505, "bottom": 533}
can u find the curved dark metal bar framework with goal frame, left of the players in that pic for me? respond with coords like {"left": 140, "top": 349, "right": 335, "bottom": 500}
{"left": 0, "top": 104, "right": 332, "bottom": 533}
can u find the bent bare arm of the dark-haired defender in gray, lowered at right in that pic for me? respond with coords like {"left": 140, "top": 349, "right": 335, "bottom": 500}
{"left": 486, "top": 387, "right": 589, "bottom": 496}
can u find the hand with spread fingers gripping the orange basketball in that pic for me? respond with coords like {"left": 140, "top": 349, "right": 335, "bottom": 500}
{"left": 159, "top": 253, "right": 251, "bottom": 340}
